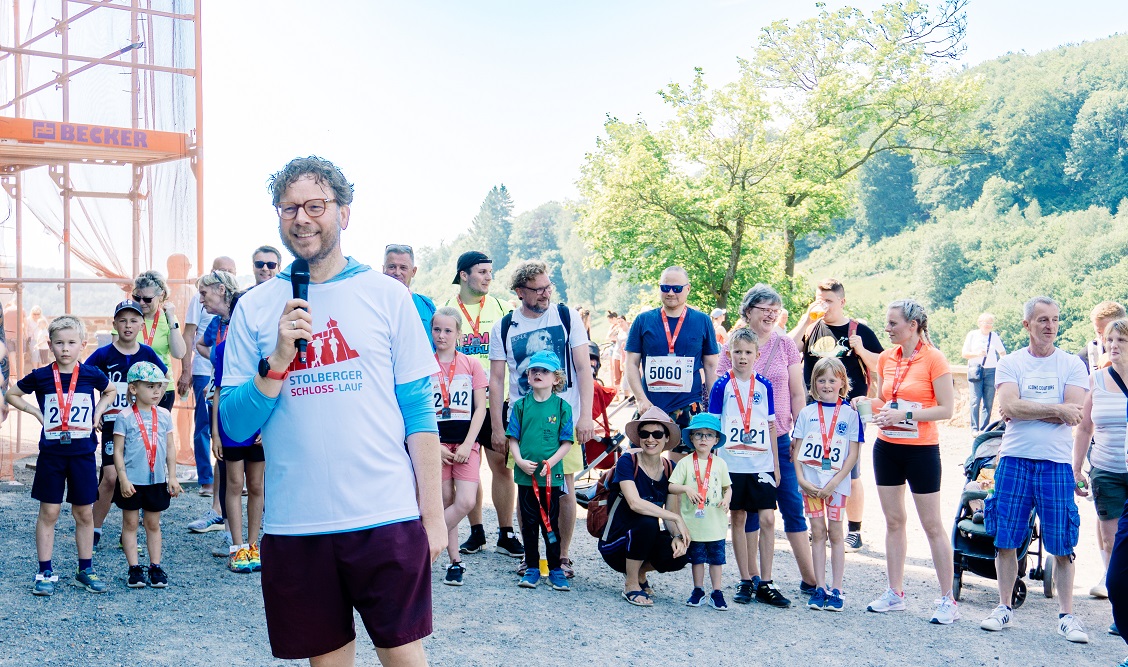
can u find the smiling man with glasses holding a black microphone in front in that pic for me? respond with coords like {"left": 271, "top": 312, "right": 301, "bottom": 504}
{"left": 220, "top": 157, "right": 447, "bottom": 665}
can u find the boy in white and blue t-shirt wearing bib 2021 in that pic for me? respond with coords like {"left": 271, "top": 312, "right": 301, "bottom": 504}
{"left": 708, "top": 328, "right": 791, "bottom": 607}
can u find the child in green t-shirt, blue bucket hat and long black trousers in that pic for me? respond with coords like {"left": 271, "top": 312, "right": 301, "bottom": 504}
{"left": 505, "top": 350, "right": 575, "bottom": 590}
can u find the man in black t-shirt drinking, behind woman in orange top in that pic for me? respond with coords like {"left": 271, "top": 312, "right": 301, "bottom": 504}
{"left": 791, "top": 278, "right": 882, "bottom": 551}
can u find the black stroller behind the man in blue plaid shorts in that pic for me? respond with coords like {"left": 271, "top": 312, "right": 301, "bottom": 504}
{"left": 952, "top": 421, "right": 1054, "bottom": 608}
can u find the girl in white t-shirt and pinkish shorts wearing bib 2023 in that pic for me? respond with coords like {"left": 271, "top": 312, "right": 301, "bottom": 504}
{"left": 791, "top": 357, "right": 865, "bottom": 612}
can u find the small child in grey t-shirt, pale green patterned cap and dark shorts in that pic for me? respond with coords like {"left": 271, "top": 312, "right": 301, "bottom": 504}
{"left": 114, "top": 361, "right": 180, "bottom": 588}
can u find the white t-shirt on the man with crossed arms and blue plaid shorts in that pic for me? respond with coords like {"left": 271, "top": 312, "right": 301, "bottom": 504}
{"left": 995, "top": 348, "right": 1089, "bottom": 463}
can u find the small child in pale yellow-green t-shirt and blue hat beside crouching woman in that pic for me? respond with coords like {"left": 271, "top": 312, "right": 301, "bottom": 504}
{"left": 670, "top": 413, "right": 732, "bottom": 611}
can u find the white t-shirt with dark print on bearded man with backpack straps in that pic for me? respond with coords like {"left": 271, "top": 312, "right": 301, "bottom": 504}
{"left": 490, "top": 304, "right": 590, "bottom": 425}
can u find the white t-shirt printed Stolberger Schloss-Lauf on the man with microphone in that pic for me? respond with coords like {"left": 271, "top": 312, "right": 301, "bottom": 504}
{"left": 223, "top": 266, "right": 439, "bottom": 535}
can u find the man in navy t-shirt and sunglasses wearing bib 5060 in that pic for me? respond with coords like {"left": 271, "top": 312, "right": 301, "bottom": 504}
{"left": 626, "top": 266, "right": 720, "bottom": 458}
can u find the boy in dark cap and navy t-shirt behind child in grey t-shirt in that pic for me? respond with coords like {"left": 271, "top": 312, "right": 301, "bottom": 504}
{"left": 86, "top": 299, "right": 168, "bottom": 548}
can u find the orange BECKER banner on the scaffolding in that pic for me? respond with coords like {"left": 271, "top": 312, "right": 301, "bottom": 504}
{"left": 0, "top": 119, "right": 188, "bottom": 155}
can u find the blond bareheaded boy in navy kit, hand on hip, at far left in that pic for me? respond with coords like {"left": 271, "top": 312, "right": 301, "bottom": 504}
{"left": 6, "top": 315, "right": 115, "bottom": 595}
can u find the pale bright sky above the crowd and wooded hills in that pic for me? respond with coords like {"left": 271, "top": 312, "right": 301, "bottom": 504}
{"left": 8, "top": 0, "right": 1128, "bottom": 273}
